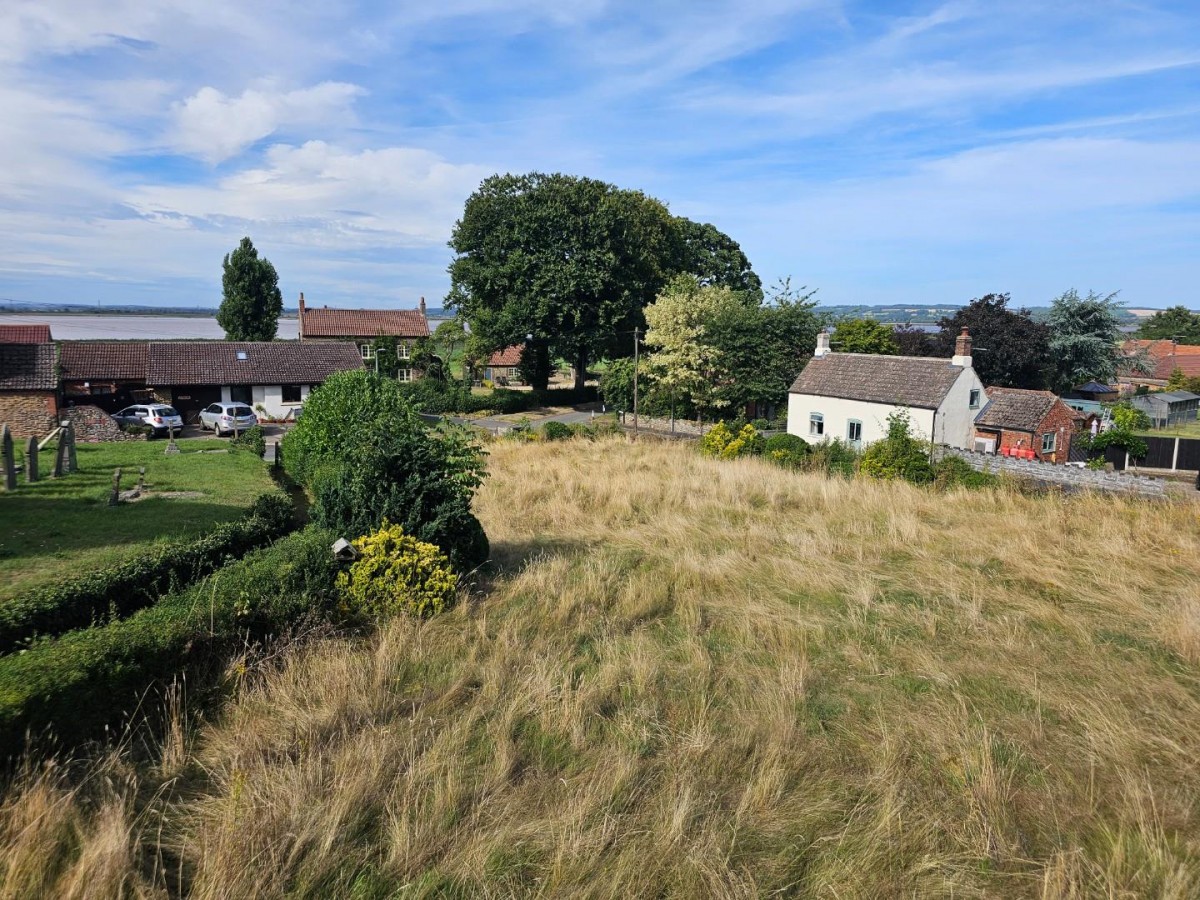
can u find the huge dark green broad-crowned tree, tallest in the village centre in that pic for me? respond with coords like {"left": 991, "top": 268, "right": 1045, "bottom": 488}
{"left": 448, "top": 173, "right": 761, "bottom": 388}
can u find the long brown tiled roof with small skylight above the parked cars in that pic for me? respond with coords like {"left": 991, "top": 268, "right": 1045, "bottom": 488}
{"left": 146, "top": 341, "right": 362, "bottom": 385}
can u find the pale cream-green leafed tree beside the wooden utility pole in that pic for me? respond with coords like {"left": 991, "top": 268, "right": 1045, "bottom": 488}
{"left": 646, "top": 275, "right": 745, "bottom": 420}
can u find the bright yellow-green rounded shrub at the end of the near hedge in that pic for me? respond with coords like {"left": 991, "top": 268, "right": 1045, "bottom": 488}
{"left": 337, "top": 522, "right": 458, "bottom": 620}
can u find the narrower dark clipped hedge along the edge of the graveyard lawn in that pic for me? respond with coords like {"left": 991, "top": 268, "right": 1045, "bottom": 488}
{"left": 0, "top": 491, "right": 293, "bottom": 653}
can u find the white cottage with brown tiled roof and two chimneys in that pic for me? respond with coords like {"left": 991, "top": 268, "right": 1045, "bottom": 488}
{"left": 787, "top": 329, "right": 988, "bottom": 449}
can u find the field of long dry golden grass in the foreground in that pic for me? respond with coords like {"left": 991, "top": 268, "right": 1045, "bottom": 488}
{"left": 0, "top": 438, "right": 1200, "bottom": 900}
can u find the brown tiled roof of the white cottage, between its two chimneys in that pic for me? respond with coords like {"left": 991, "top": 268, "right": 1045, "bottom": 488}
{"left": 790, "top": 353, "right": 964, "bottom": 409}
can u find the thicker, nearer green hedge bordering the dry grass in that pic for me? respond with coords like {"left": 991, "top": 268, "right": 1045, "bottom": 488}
{"left": 0, "top": 528, "right": 338, "bottom": 758}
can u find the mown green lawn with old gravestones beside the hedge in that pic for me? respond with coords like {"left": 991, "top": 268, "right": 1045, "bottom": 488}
{"left": 0, "top": 439, "right": 272, "bottom": 599}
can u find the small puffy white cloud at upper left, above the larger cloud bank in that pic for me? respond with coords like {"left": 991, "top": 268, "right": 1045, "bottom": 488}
{"left": 168, "top": 82, "right": 365, "bottom": 163}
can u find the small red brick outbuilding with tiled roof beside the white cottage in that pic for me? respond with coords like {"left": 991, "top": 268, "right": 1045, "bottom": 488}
{"left": 974, "top": 388, "right": 1087, "bottom": 463}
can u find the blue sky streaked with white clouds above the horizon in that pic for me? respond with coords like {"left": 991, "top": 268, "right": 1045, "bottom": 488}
{"left": 0, "top": 0, "right": 1200, "bottom": 307}
